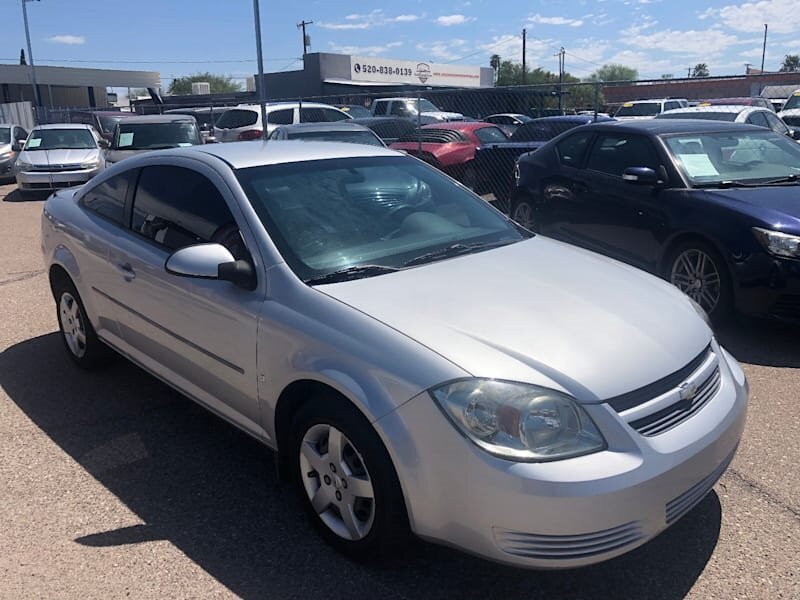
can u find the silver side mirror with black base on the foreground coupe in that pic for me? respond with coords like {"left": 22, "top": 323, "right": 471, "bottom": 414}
{"left": 164, "top": 244, "right": 257, "bottom": 290}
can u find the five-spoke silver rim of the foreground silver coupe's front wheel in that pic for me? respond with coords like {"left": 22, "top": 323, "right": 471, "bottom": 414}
{"left": 300, "top": 424, "right": 375, "bottom": 541}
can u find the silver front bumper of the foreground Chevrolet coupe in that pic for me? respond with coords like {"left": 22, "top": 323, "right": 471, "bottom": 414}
{"left": 376, "top": 346, "right": 747, "bottom": 569}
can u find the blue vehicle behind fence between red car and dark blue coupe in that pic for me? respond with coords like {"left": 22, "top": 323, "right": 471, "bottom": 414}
{"left": 473, "top": 115, "right": 613, "bottom": 206}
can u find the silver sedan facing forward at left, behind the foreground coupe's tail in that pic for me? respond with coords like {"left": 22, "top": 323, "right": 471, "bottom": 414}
{"left": 14, "top": 123, "right": 107, "bottom": 195}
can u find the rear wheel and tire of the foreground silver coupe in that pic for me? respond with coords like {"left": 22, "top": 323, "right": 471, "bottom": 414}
{"left": 53, "top": 279, "right": 114, "bottom": 370}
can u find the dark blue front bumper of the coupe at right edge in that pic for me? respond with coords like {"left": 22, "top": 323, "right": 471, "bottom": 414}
{"left": 733, "top": 252, "right": 800, "bottom": 322}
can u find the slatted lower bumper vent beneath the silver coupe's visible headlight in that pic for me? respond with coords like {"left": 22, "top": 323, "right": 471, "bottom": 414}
{"left": 494, "top": 521, "right": 644, "bottom": 560}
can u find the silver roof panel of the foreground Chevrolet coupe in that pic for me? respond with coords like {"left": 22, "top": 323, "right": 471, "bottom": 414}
{"left": 184, "top": 140, "right": 404, "bottom": 169}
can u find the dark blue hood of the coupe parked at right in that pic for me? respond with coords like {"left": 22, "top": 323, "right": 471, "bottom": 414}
{"left": 703, "top": 185, "right": 800, "bottom": 231}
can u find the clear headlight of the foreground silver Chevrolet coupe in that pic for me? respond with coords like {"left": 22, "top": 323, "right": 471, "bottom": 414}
{"left": 430, "top": 379, "right": 607, "bottom": 462}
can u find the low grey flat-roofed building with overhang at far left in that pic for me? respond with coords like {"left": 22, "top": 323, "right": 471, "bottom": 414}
{"left": 0, "top": 65, "right": 161, "bottom": 108}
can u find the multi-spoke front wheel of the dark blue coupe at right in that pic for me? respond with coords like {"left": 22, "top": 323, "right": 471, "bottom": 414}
{"left": 664, "top": 240, "right": 733, "bottom": 324}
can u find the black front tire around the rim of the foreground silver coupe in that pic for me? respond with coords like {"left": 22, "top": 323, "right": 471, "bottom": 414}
{"left": 287, "top": 396, "right": 408, "bottom": 560}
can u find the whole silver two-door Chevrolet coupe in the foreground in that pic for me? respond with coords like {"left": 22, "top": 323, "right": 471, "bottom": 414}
{"left": 42, "top": 141, "right": 747, "bottom": 568}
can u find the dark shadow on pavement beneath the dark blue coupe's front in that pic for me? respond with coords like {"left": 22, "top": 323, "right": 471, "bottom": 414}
{"left": 715, "top": 316, "right": 800, "bottom": 368}
